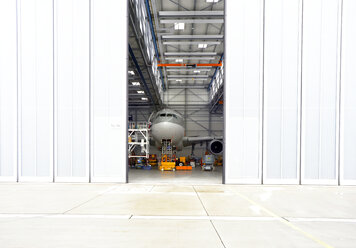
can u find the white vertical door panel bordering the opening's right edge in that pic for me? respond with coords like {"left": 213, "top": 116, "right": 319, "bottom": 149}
{"left": 225, "top": 0, "right": 263, "bottom": 183}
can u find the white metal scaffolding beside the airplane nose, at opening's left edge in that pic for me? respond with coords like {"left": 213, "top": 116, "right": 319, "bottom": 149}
{"left": 128, "top": 122, "right": 150, "bottom": 159}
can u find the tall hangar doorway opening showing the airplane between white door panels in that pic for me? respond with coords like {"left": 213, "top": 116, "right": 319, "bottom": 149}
{"left": 128, "top": 0, "right": 224, "bottom": 183}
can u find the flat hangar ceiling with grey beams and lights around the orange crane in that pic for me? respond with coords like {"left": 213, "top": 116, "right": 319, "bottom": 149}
{"left": 151, "top": 0, "right": 224, "bottom": 89}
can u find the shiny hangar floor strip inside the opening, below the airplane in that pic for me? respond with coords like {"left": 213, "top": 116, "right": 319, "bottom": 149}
{"left": 129, "top": 166, "right": 222, "bottom": 184}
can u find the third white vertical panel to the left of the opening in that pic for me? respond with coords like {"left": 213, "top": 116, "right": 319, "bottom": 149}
{"left": 19, "top": 0, "right": 53, "bottom": 181}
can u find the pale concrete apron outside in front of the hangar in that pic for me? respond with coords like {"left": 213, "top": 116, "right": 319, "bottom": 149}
{"left": 0, "top": 183, "right": 356, "bottom": 248}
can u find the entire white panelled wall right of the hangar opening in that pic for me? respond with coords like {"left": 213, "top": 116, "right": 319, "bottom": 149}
{"left": 225, "top": 0, "right": 356, "bottom": 185}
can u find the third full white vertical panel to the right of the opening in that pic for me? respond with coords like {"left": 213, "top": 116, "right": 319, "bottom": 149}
{"left": 301, "top": 0, "right": 340, "bottom": 184}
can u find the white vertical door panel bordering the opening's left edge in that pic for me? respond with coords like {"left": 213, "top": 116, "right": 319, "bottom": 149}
{"left": 91, "top": 0, "right": 127, "bottom": 182}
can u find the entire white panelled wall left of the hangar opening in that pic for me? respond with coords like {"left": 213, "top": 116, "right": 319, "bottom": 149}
{"left": 0, "top": 0, "right": 127, "bottom": 182}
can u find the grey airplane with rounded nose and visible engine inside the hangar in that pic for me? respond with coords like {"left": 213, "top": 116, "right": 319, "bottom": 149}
{"left": 148, "top": 108, "right": 224, "bottom": 155}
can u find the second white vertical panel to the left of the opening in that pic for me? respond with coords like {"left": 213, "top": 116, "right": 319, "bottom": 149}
{"left": 54, "top": 0, "right": 89, "bottom": 182}
